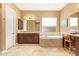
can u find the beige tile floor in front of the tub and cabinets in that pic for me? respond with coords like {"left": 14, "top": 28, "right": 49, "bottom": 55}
{"left": 1, "top": 44, "right": 75, "bottom": 56}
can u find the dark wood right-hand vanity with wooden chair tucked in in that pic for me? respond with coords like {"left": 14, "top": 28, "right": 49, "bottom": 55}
{"left": 64, "top": 34, "right": 79, "bottom": 56}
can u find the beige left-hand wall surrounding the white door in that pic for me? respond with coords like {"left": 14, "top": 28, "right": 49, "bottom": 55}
{"left": 2, "top": 3, "right": 21, "bottom": 50}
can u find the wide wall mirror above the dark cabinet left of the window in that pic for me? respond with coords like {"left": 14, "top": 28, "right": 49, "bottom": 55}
{"left": 23, "top": 20, "right": 40, "bottom": 32}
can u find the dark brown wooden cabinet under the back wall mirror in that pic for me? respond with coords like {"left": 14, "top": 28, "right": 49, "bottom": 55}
{"left": 17, "top": 33, "right": 39, "bottom": 44}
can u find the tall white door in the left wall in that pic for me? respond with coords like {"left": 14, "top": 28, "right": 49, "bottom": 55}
{"left": 5, "top": 6, "right": 16, "bottom": 49}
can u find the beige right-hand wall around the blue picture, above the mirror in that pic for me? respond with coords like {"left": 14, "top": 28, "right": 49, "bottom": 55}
{"left": 60, "top": 3, "right": 79, "bottom": 33}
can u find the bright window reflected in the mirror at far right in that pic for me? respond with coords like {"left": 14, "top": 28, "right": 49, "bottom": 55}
{"left": 70, "top": 17, "right": 78, "bottom": 32}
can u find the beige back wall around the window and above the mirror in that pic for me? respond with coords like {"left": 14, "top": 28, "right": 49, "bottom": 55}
{"left": 21, "top": 11, "right": 60, "bottom": 32}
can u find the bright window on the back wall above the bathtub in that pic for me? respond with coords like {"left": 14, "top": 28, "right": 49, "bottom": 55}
{"left": 42, "top": 17, "right": 57, "bottom": 32}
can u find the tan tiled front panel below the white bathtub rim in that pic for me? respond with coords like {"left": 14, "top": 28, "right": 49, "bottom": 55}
{"left": 40, "top": 39, "right": 63, "bottom": 48}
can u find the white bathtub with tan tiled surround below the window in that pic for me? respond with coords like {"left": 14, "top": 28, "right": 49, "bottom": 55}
{"left": 40, "top": 35, "right": 63, "bottom": 48}
